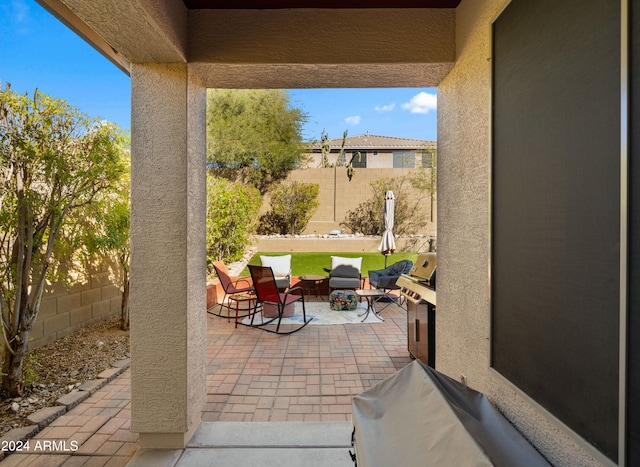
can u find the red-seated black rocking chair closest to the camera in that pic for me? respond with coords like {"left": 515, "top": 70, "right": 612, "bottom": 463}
{"left": 249, "top": 264, "right": 313, "bottom": 334}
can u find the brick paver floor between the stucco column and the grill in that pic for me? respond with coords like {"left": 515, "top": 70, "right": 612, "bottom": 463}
{"left": 202, "top": 302, "right": 411, "bottom": 422}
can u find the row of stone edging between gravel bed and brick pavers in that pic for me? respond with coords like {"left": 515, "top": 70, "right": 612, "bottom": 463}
{"left": 0, "top": 358, "right": 131, "bottom": 460}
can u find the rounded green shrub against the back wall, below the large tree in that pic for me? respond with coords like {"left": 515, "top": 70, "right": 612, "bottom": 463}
{"left": 258, "top": 182, "right": 320, "bottom": 235}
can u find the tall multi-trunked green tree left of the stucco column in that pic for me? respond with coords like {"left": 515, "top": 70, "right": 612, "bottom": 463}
{"left": 0, "top": 85, "right": 124, "bottom": 396}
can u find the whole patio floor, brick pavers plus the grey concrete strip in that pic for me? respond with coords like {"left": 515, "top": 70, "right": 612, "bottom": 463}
{"left": 2, "top": 304, "right": 411, "bottom": 466}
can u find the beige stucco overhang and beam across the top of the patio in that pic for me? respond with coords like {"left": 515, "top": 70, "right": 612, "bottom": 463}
{"left": 38, "top": 0, "right": 460, "bottom": 88}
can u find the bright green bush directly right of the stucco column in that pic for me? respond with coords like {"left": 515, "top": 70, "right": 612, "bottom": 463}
{"left": 207, "top": 176, "right": 262, "bottom": 272}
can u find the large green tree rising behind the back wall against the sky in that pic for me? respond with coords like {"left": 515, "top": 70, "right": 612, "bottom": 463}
{"left": 207, "top": 89, "right": 307, "bottom": 194}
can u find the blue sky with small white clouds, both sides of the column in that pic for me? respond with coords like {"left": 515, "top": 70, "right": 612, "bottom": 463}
{"left": 0, "top": 0, "right": 437, "bottom": 140}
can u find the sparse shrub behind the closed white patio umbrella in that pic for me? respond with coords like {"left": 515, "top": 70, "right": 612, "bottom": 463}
{"left": 340, "top": 169, "right": 435, "bottom": 235}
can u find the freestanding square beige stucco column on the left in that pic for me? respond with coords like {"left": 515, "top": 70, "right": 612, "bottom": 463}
{"left": 126, "top": 64, "right": 206, "bottom": 448}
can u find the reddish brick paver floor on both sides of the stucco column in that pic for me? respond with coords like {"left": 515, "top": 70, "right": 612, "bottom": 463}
{"left": 1, "top": 298, "right": 411, "bottom": 467}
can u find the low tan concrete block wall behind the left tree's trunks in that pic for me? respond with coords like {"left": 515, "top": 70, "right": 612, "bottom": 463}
{"left": 29, "top": 264, "right": 122, "bottom": 350}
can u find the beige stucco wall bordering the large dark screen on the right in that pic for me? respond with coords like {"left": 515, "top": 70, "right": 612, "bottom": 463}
{"left": 436, "top": 0, "right": 601, "bottom": 466}
